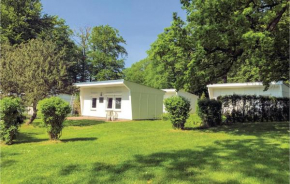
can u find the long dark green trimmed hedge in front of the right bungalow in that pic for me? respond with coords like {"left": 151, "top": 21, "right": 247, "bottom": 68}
{"left": 218, "top": 95, "right": 289, "bottom": 123}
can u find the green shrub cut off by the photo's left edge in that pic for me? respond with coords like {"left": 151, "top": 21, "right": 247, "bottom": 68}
{"left": 0, "top": 97, "right": 24, "bottom": 144}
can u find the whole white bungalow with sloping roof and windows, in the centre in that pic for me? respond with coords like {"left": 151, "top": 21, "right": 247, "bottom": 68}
{"left": 75, "top": 79, "right": 165, "bottom": 120}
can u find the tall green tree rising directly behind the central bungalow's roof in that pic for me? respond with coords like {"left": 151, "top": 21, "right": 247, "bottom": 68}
{"left": 88, "top": 25, "right": 127, "bottom": 80}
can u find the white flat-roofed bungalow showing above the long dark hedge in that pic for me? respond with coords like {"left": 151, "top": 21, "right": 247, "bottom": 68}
{"left": 207, "top": 82, "right": 289, "bottom": 99}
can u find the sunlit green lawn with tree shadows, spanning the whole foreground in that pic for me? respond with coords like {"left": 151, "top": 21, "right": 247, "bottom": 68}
{"left": 1, "top": 117, "right": 289, "bottom": 184}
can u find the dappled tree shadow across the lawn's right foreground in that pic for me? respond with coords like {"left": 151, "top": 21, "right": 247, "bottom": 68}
{"left": 53, "top": 139, "right": 289, "bottom": 184}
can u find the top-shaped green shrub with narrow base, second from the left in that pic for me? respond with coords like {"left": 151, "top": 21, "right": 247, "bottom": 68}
{"left": 37, "top": 97, "right": 71, "bottom": 140}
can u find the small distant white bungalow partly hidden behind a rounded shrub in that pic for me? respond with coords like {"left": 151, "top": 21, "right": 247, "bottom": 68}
{"left": 162, "top": 89, "right": 198, "bottom": 113}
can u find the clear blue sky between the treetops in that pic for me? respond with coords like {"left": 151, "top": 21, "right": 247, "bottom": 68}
{"left": 41, "top": 0, "right": 186, "bottom": 67}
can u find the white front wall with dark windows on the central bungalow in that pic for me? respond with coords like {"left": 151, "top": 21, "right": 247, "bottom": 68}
{"left": 80, "top": 86, "right": 132, "bottom": 119}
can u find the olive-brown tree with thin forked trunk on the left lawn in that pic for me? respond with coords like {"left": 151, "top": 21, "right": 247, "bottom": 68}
{"left": 0, "top": 39, "right": 73, "bottom": 124}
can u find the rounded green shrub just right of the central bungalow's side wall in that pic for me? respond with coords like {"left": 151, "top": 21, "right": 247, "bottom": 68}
{"left": 164, "top": 96, "right": 190, "bottom": 129}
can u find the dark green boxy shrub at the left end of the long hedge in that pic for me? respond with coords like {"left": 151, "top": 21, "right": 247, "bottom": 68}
{"left": 197, "top": 99, "right": 222, "bottom": 127}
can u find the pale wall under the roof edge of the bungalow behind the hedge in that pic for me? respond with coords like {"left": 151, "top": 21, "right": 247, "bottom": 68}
{"left": 209, "top": 85, "right": 282, "bottom": 99}
